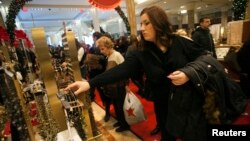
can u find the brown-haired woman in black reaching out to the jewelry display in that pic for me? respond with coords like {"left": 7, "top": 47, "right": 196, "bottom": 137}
{"left": 65, "top": 6, "right": 211, "bottom": 141}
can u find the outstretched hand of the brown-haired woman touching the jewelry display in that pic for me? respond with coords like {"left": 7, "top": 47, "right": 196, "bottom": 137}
{"left": 64, "top": 81, "right": 90, "bottom": 95}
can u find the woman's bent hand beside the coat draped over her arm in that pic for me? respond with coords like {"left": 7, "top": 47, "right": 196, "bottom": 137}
{"left": 167, "top": 71, "right": 189, "bottom": 86}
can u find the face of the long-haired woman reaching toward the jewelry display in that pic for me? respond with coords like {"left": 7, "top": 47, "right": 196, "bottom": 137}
{"left": 141, "top": 14, "right": 155, "bottom": 42}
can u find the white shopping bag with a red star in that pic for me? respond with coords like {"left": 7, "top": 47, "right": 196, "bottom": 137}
{"left": 123, "top": 91, "right": 147, "bottom": 125}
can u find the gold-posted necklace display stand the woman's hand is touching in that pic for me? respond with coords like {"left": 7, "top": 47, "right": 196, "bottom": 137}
{"left": 32, "top": 28, "right": 100, "bottom": 141}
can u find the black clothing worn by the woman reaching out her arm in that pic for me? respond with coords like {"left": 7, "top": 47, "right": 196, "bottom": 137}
{"left": 89, "top": 36, "right": 206, "bottom": 141}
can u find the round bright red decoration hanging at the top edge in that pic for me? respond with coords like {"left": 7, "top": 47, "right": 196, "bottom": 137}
{"left": 88, "top": 0, "right": 121, "bottom": 10}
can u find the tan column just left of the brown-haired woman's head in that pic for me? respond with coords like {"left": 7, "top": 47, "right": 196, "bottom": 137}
{"left": 126, "top": 0, "right": 137, "bottom": 35}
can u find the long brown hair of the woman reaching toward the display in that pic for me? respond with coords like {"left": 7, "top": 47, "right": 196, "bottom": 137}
{"left": 140, "top": 6, "right": 173, "bottom": 49}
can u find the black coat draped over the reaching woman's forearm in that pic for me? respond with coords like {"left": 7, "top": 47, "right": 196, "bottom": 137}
{"left": 182, "top": 55, "right": 247, "bottom": 124}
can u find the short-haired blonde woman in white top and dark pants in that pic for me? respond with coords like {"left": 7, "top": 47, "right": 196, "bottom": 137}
{"left": 96, "top": 36, "right": 129, "bottom": 132}
